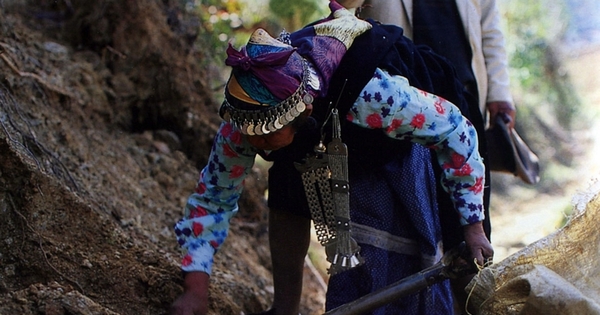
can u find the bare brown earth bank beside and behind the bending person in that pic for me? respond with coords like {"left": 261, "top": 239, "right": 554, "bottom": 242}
{"left": 0, "top": 0, "right": 324, "bottom": 315}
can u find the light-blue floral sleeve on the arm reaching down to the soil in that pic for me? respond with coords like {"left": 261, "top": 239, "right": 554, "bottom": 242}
{"left": 175, "top": 123, "right": 256, "bottom": 274}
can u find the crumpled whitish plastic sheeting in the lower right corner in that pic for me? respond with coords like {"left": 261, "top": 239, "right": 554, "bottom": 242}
{"left": 467, "top": 182, "right": 600, "bottom": 315}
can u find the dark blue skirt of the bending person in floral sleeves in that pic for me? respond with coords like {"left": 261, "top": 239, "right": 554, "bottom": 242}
{"left": 326, "top": 145, "right": 453, "bottom": 315}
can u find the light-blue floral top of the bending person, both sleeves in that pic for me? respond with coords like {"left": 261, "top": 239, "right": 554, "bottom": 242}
{"left": 175, "top": 69, "right": 485, "bottom": 274}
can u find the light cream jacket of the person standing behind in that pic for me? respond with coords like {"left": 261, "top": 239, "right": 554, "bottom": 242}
{"left": 360, "top": 0, "right": 513, "bottom": 116}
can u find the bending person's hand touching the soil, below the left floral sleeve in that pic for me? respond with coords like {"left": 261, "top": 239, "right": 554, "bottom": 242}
{"left": 169, "top": 272, "right": 209, "bottom": 315}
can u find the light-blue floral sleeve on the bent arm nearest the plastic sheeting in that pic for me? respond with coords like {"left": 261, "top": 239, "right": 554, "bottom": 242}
{"left": 347, "top": 69, "right": 485, "bottom": 225}
